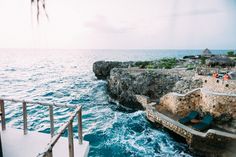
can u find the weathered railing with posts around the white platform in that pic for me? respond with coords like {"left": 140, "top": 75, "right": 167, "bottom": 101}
{"left": 0, "top": 98, "right": 83, "bottom": 157}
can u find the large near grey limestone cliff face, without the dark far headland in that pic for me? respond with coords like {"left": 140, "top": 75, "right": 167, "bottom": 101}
{"left": 108, "top": 68, "right": 197, "bottom": 109}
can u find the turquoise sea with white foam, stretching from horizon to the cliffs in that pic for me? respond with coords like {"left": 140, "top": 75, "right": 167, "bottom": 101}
{"left": 0, "top": 50, "right": 229, "bottom": 157}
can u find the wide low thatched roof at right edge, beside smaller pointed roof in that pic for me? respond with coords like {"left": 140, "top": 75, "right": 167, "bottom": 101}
{"left": 206, "top": 55, "right": 235, "bottom": 67}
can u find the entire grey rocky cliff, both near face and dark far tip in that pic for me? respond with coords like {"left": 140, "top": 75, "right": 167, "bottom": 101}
{"left": 93, "top": 62, "right": 202, "bottom": 109}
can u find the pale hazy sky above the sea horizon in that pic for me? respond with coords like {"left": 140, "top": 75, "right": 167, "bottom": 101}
{"left": 0, "top": 0, "right": 236, "bottom": 49}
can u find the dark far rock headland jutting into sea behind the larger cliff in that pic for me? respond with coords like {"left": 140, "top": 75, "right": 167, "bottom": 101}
{"left": 93, "top": 61, "right": 133, "bottom": 79}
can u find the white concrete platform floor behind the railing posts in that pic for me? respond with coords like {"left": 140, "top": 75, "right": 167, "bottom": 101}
{"left": 1, "top": 128, "right": 89, "bottom": 157}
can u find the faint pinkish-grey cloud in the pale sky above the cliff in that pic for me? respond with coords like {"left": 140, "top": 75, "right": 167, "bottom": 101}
{"left": 84, "top": 15, "right": 134, "bottom": 33}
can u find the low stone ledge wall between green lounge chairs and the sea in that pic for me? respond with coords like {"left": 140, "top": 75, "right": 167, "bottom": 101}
{"left": 146, "top": 105, "right": 236, "bottom": 156}
